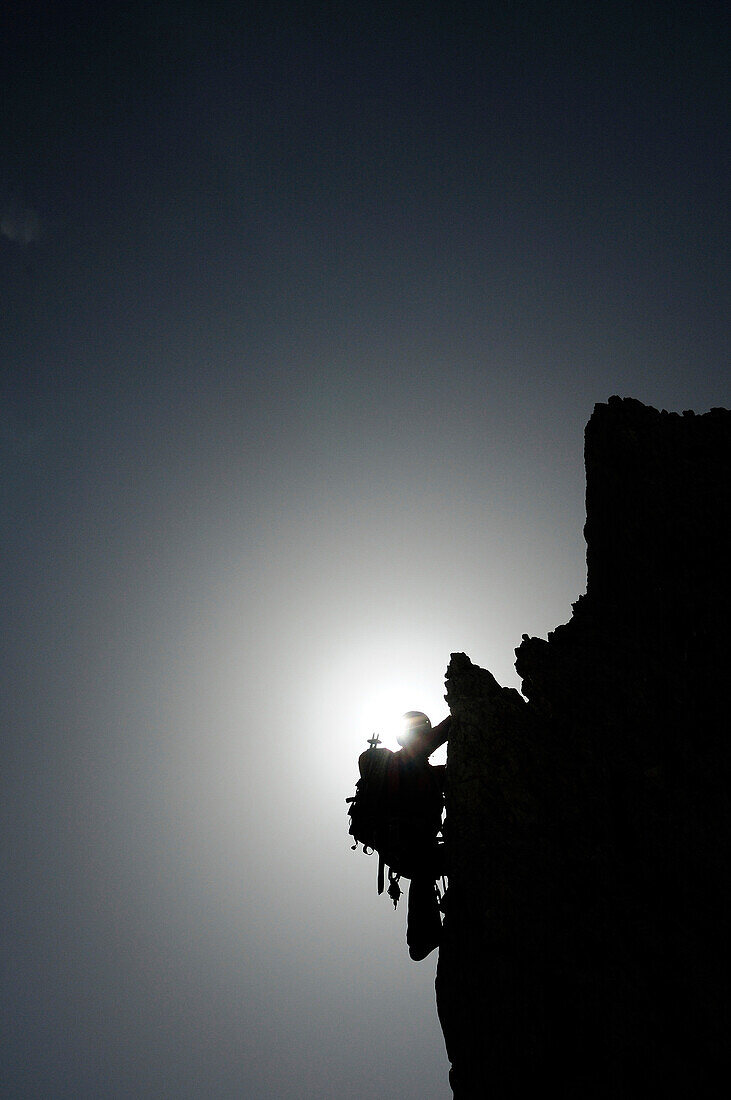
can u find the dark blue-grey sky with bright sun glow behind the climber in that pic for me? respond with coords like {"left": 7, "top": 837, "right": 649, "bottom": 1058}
{"left": 0, "top": 0, "right": 731, "bottom": 1100}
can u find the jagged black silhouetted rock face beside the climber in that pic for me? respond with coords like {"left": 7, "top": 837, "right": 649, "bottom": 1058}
{"left": 436, "top": 397, "right": 731, "bottom": 1100}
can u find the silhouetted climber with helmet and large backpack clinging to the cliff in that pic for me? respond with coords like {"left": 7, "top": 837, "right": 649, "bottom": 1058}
{"left": 347, "top": 711, "right": 452, "bottom": 960}
